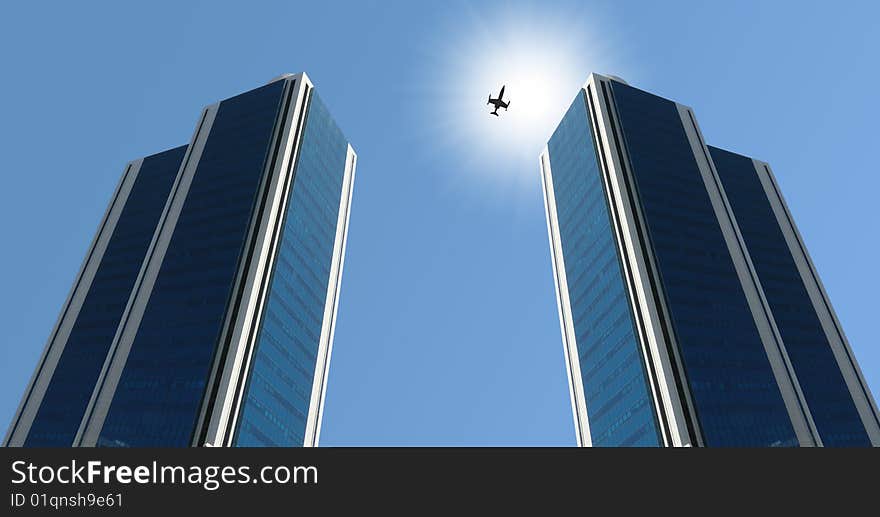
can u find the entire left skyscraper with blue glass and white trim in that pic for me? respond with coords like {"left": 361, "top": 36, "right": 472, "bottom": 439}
{"left": 6, "top": 74, "right": 356, "bottom": 447}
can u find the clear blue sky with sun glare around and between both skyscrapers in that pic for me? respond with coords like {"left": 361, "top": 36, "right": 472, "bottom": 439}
{"left": 0, "top": 1, "right": 880, "bottom": 445}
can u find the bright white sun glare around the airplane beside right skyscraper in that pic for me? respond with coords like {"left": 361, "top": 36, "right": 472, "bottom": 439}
{"left": 416, "top": 5, "right": 615, "bottom": 191}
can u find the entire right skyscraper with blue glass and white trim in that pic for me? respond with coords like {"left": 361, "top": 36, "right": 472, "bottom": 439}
{"left": 540, "top": 74, "right": 880, "bottom": 447}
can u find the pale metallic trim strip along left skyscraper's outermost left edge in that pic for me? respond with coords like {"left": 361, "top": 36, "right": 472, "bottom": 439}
{"left": 3, "top": 158, "right": 143, "bottom": 447}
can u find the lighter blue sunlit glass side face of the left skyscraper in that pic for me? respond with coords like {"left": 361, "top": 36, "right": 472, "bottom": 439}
{"left": 235, "top": 94, "right": 348, "bottom": 447}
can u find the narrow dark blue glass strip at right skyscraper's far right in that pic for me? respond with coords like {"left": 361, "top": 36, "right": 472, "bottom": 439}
{"left": 709, "top": 147, "right": 871, "bottom": 447}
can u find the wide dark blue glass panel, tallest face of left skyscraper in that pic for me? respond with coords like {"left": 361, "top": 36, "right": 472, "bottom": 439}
{"left": 98, "top": 81, "right": 285, "bottom": 447}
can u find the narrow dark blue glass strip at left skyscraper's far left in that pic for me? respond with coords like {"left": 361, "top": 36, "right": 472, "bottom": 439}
{"left": 25, "top": 146, "right": 186, "bottom": 447}
